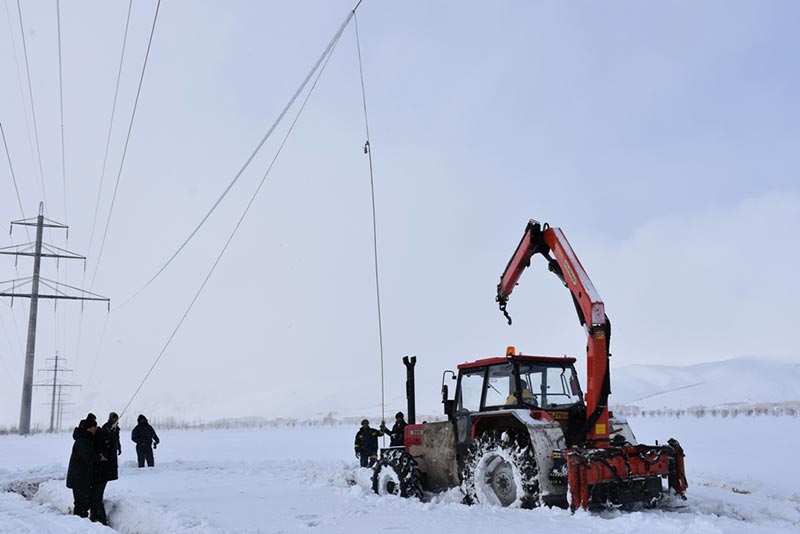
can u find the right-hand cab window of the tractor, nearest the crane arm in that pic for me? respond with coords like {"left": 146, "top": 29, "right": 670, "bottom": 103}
{"left": 515, "top": 363, "right": 583, "bottom": 409}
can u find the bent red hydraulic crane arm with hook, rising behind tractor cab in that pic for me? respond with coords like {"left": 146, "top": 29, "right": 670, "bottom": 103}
{"left": 496, "top": 220, "right": 611, "bottom": 443}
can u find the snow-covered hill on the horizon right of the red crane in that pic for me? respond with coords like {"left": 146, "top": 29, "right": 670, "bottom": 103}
{"left": 610, "top": 358, "right": 800, "bottom": 409}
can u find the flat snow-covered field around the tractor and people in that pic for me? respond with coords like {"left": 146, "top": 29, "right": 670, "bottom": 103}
{"left": 0, "top": 417, "right": 800, "bottom": 534}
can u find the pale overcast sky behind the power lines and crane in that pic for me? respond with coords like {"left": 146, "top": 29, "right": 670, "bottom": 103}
{"left": 0, "top": 0, "right": 800, "bottom": 425}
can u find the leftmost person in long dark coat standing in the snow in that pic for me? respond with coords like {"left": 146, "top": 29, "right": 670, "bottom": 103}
{"left": 67, "top": 419, "right": 104, "bottom": 517}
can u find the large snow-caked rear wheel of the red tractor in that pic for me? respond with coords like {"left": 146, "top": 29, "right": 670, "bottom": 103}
{"left": 462, "top": 431, "right": 540, "bottom": 508}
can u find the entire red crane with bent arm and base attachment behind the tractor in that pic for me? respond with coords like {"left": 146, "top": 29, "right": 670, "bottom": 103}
{"left": 497, "top": 220, "right": 687, "bottom": 510}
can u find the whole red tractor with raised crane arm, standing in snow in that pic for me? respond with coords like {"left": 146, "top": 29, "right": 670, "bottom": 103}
{"left": 372, "top": 220, "right": 687, "bottom": 510}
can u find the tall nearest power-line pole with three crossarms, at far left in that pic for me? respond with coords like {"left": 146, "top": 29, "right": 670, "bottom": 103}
{"left": 0, "top": 202, "right": 111, "bottom": 434}
